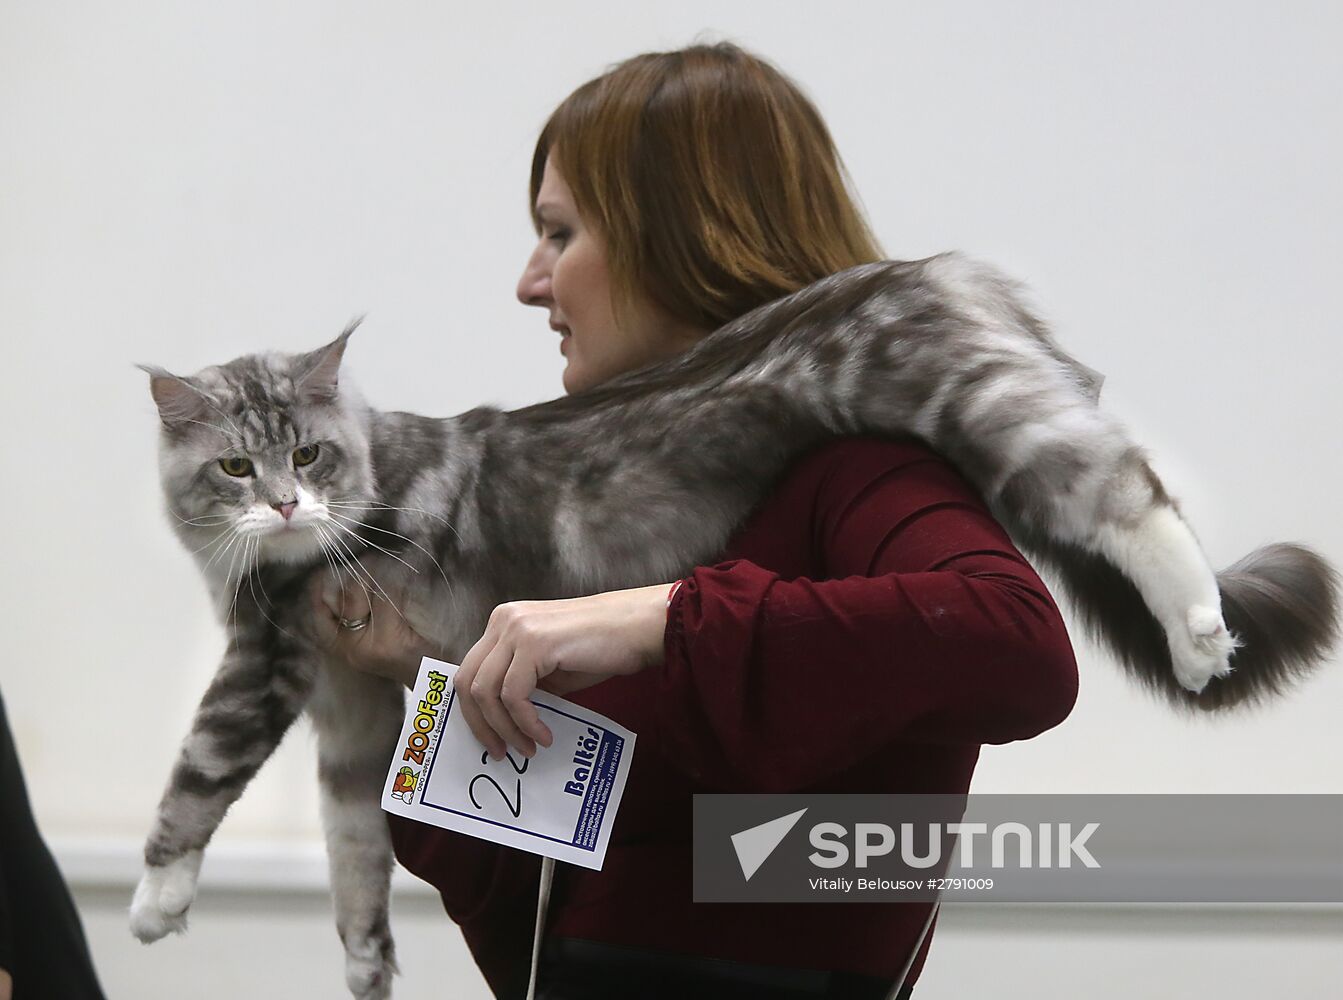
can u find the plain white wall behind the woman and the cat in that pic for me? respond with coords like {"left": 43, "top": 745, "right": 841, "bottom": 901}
{"left": 0, "top": 0, "right": 1343, "bottom": 1000}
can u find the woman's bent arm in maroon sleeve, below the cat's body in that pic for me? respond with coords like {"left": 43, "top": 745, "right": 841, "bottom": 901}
{"left": 657, "top": 439, "right": 1077, "bottom": 791}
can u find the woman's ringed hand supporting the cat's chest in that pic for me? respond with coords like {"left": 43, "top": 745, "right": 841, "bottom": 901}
{"left": 309, "top": 556, "right": 442, "bottom": 687}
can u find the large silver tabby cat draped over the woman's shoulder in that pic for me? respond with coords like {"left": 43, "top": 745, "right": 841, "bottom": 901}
{"left": 132, "top": 254, "right": 1338, "bottom": 999}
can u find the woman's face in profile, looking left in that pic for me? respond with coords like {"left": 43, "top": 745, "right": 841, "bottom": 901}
{"left": 517, "top": 158, "right": 706, "bottom": 393}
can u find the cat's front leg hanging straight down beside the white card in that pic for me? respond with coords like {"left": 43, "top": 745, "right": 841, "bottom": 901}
{"left": 312, "top": 666, "right": 404, "bottom": 1000}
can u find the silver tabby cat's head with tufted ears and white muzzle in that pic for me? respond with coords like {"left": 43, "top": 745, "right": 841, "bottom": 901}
{"left": 142, "top": 323, "right": 373, "bottom": 574}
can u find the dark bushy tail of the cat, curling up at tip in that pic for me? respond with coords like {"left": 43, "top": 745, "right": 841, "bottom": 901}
{"left": 1023, "top": 537, "right": 1339, "bottom": 711}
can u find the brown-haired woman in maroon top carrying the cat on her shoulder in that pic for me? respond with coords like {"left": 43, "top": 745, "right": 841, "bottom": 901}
{"left": 308, "top": 44, "right": 1077, "bottom": 1000}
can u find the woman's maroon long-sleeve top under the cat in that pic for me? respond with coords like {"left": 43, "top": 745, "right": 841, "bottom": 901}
{"left": 389, "top": 438, "right": 1077, "bottom": 997}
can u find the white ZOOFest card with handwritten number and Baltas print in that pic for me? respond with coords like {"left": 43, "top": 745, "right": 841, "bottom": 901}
{"left": 383, "top": 656, "right": 634, "bottom": 870}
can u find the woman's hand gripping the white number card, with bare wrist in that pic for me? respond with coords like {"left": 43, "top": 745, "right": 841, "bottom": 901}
{"left": 453, "top": 584, "right": 672, "bottom": 758}
